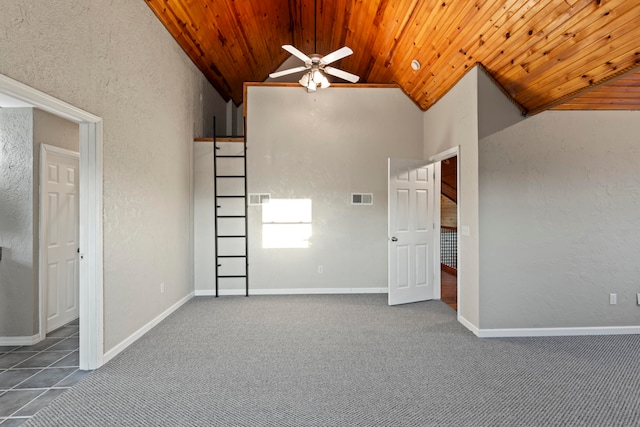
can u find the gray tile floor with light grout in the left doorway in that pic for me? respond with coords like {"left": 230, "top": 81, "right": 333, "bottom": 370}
{"left": 0, "top": 320, "right": 89, "bottom": 427}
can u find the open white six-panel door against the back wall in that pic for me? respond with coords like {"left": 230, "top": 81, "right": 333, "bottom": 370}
{"left": 389, "top": 159, "right": 434, "bottom": 305}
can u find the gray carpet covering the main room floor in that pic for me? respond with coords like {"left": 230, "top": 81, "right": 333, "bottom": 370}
{"left": 24, "top": 295, "right": 640, "bottom": 427}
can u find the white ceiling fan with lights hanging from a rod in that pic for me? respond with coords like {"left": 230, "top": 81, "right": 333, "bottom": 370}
{"left": 269, "top": 0, "right": 360, "bottom": 92}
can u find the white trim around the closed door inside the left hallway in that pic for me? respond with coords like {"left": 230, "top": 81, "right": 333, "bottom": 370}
{"left": 38, "top": 144, "right": 80, "bottom": 341}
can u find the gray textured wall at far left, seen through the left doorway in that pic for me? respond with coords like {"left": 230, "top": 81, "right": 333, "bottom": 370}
{"left": 0, "top": 108, "right": 38, "bottom": 337}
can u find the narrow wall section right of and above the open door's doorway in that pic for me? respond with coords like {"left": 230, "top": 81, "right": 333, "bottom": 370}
{"left": 424, "top": 67, "right": 479, "bottom": 326}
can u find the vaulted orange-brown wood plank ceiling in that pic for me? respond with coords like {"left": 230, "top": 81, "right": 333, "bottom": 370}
{"left": 145, "top": 0, "right": 640, "bottom": 113}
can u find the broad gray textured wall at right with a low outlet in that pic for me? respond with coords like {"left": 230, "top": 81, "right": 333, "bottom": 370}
{"left": 479, "top": 111, "right": 640, "bottom": 329}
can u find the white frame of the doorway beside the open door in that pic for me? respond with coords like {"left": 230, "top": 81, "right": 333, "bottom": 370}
{"left": 429, "top": 145, "right": 462, "bottom": 318}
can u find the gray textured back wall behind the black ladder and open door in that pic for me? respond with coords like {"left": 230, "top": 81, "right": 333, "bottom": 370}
{"left": 196, "top": 86, "right": 422, "bottom": 292}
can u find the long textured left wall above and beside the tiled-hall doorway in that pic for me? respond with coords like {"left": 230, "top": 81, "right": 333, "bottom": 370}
{"left": 0, "top": 0, "right": 225, "bottom": 351}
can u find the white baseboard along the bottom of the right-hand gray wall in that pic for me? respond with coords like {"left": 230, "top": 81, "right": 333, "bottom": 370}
{"left": 474, "top": 326, "right": 640, "bottom": 338}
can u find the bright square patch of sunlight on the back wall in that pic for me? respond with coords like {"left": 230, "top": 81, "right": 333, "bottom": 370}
{"left": 262, "top": 199, "right": 312, "bottom": 249}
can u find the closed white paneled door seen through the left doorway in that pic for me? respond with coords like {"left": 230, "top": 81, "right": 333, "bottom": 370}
{"left": 40, "top": 146, "right": 79, "bottom": 332}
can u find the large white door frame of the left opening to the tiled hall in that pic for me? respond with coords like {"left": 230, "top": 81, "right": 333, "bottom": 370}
{"left": 0, "top": 74, "right": 104, "bottom": 370}
